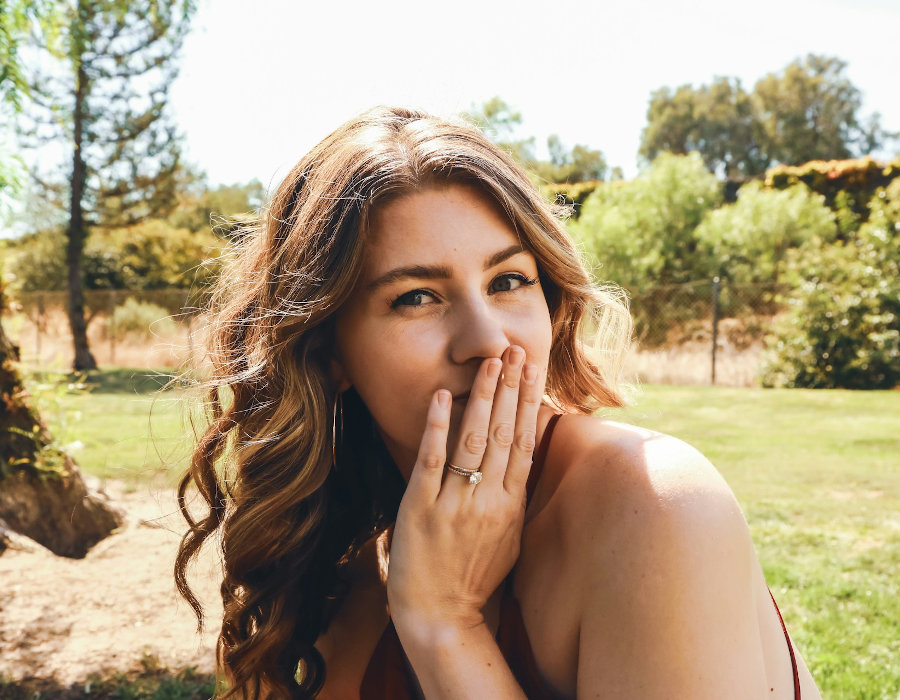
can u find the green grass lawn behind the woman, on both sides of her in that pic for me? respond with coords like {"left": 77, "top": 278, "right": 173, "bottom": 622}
{"left": 26, "top": 370, "right": 900, "bottom": 700}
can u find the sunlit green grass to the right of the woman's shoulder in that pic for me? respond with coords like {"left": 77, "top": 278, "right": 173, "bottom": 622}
{"left": 609, "top": 386, "right": 900, "bottom": 700}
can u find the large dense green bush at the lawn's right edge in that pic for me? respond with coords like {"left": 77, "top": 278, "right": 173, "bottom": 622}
{"left": 762, "top": 180, "right": 900, "bottom": 389}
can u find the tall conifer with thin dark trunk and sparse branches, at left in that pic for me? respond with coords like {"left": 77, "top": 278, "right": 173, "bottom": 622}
{"left": 20, "top": 0, "right": 194, "bottom": 370}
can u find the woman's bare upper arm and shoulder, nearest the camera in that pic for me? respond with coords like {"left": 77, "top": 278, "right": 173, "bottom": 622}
{"left": 567, "top": 436, "right": 793, "bottom": 700}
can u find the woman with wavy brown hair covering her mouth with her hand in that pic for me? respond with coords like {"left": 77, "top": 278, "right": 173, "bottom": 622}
{"left": 176, "top": 109, "right": 818, "bottom": 698}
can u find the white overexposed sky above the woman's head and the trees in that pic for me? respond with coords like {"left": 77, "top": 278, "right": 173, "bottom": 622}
{"left": 172, "top": 0, "right": 900, "bottom": 186}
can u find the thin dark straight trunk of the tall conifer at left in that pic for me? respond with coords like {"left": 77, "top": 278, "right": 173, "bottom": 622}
{"left": 66, "top": 63, "right": 97, "bottom": 371}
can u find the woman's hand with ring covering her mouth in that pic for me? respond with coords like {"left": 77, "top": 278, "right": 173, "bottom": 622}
{"left": 387, "top": 346, "right": 544, "bottom": 635}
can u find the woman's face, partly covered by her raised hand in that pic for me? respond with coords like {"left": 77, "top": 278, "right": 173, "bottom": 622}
{"left": 336, "top": 184, "right": 551, "bottom": 478}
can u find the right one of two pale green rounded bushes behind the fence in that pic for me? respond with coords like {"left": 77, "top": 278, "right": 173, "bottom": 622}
{"left": 696, "top": 182, "right": 837, "bottom": 283}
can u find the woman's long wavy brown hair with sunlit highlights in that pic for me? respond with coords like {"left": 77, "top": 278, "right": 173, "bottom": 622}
{"left": 175, "top": 108, "right": 631, "bottom": 699}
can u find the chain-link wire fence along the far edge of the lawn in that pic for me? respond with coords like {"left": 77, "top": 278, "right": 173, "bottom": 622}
{"left": 4, "top": 278, "right": 789, "bottom": 386}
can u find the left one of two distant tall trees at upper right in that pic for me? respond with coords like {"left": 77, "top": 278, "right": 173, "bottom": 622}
{"left": 640, "top": 77, "right": 769, "bottom": 179}
